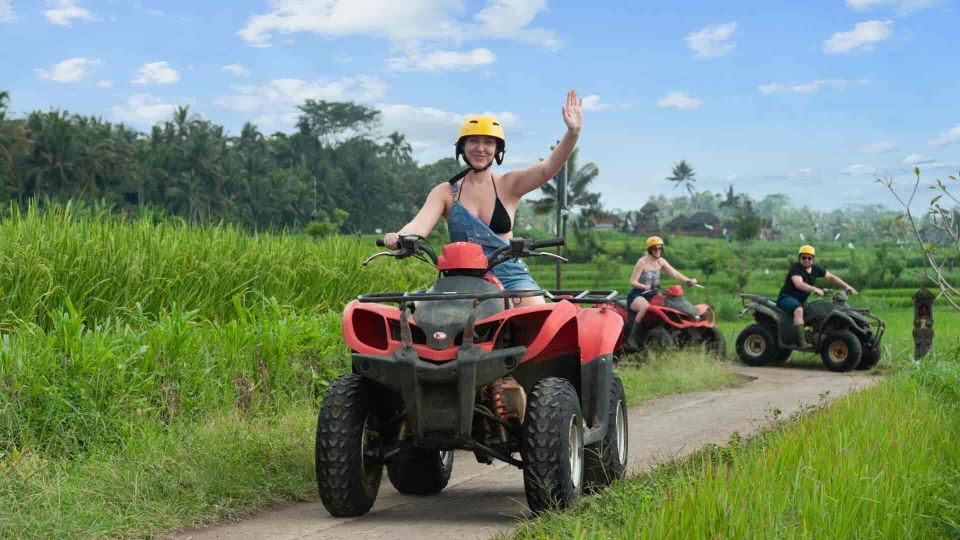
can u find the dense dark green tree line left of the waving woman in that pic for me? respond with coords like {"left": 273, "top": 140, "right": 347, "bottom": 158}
{"left": 0, "top": 92, "right": 461, "bottom": 232}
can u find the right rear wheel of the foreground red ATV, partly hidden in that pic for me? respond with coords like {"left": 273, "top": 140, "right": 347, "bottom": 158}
{"left": 583, "top": 375, "right": 629, "bottom": 491}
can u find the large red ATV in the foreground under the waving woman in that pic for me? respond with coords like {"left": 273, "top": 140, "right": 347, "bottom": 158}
{"left": 316, "top": 235, "right": 627, "bottom": 517}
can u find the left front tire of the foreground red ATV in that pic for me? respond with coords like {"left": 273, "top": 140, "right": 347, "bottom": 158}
{"left": 315, "top": 375, "right": 383, "bottom": 517}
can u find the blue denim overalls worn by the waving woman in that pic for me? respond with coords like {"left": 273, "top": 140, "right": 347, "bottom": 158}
{"left": 447, "top": 184, "right": 540, "bottom": 291}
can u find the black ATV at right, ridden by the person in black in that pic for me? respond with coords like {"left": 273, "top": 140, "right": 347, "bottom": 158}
{"left": 736, "top": 289, "right": 886, "bottom": 371}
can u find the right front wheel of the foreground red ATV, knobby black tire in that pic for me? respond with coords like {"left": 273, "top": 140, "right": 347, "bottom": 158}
{"left": 520, "top": 377, "right": 584, "bottom": 514}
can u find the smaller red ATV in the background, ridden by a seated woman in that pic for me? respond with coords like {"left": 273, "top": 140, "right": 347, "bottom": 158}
{"left": 617, "top": 285, "right": 727, "bottom": 358}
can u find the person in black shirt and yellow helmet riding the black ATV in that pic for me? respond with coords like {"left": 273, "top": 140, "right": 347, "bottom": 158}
{"left": 777, "top": 245, "right": 857, "bottom": 349}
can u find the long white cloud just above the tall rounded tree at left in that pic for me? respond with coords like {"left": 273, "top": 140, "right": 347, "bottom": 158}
{"left": 213, "top": 77, "right": 387, "bottom": 118}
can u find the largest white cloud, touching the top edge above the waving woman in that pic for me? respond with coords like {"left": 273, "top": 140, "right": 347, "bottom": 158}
{"left": 238, "top": 0, "right": 560, "bottom": 48}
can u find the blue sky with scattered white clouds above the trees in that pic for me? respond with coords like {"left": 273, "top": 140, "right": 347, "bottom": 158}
{"left": 0, "top": 0, "right": 960, "bottom": 209}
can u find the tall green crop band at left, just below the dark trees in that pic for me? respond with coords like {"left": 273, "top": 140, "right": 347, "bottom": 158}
{"left": 0, "top": 204, "right": 430, "bottom": 328}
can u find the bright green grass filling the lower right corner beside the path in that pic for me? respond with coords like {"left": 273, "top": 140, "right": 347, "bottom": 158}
{"left": 517, "top": 355, "right": 960, "bottom": 538}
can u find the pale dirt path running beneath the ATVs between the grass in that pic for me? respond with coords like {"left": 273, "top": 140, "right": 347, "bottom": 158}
{"left": 174, "top": 366, "right": 877, "bottom": 540}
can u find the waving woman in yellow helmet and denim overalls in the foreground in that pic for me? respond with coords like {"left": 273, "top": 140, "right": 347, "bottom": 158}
{"left": 383, "top": 90, "right": 583, "bottom": 305}
